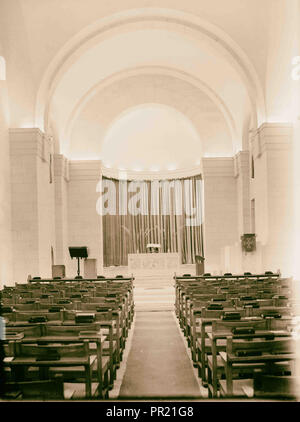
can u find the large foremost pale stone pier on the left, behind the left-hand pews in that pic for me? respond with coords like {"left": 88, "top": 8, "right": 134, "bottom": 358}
{"left": 9, "top": 128, "right": 55, "bottom": 282}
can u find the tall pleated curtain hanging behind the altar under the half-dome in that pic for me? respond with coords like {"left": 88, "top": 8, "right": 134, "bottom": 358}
{"left": 102, "top": 175, "right": 204, "bottom": 267}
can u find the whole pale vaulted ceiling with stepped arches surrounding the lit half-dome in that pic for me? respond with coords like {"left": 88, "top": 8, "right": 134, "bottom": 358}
{"left": 0, "top": 0, "right": 272, "bottom": 169}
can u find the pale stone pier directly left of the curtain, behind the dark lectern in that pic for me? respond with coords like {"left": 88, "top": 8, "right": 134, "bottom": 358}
{"left": 67, "top": 161, "right": 103, "bottom": 276}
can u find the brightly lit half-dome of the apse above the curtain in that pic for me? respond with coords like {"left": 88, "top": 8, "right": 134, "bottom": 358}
{"left": 100, "top": 104, "right": 202, "bottom": 171}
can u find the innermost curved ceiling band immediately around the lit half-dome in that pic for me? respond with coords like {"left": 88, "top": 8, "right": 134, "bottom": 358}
{"left": 67, "top": 69, "right": 232, "bottom": 164}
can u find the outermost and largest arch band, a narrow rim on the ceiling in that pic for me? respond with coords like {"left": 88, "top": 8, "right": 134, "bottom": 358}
{"left": 36, "top": 8, "right": 265, "bottom": 141}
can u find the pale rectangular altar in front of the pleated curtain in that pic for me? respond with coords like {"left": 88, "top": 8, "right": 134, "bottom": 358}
{"left": 128, "top": 253, "right": 180, "bottom": 275}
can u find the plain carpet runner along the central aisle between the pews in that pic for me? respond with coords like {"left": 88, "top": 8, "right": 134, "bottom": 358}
{"left": 119, "top": 311, "right": 201, "bottom": 399}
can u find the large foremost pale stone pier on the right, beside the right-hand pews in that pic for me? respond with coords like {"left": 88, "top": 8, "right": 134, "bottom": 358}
{"left": 251, "top": 123, "right": 293, "bottom": 276}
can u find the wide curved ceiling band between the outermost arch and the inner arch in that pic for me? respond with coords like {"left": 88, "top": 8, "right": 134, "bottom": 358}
{"left": 50, "top": 23, "right": 254, "bottom": 154}
